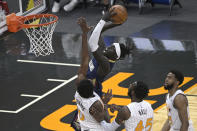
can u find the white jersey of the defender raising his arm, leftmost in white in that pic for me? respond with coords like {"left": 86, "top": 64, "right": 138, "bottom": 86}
{"left": 75, "top": 91, "right": 104, "bottom": 131}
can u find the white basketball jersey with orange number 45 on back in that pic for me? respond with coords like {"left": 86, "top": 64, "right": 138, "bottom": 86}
{"left": 125, "top": 101, "right": 154, "bottom": 131}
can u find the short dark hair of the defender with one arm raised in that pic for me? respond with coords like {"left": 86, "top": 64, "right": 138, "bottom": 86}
{"left": 77, "top": 79, "right": 94, "bottom": 98}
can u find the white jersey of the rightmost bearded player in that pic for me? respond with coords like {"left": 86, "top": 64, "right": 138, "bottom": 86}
{"left": 166, "top": 90, "right": 194, "bottom": 131}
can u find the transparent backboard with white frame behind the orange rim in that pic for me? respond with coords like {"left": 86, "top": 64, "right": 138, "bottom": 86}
{"left": 0, "top": 0, "right": 48, "bottom": 35}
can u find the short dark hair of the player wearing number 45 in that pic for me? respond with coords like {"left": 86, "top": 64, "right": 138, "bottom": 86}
{"left": 134, "top": 81, "right": 149, "bottom": 100}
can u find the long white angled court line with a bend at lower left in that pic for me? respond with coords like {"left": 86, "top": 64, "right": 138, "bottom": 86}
{"left": 0, "top": 75, "right": 77, "bottom": 113}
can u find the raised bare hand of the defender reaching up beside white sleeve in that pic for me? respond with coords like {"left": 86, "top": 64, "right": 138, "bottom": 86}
{"left": 77, "top": 17, "right": 93, "bottom": 33}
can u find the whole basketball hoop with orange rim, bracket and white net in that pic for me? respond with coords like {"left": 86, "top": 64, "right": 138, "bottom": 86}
{"left": 6, "top": 14, "right": 58, "bottom": 57}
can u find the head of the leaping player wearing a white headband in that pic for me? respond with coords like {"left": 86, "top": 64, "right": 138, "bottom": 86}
{"left": 103, "top": 43, "right": 130, "bottom": 61}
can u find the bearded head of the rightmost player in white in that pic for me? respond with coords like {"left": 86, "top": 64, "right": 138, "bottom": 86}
{"left": 164, "top": 70, "right": 184, "bottom": 90}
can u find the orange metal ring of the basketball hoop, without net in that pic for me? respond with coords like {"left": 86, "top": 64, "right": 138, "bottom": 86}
{"left": 20, "top": 14, "right": 58, "bottom": 28}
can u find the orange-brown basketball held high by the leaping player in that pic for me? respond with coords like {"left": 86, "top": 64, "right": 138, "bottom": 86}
{"left": 109, "top": 5, "right": 128, "bottom": 24}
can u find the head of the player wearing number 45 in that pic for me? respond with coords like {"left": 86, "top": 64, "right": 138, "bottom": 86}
{"left": 128, "top": 81, "right": 149, "bottom": 101}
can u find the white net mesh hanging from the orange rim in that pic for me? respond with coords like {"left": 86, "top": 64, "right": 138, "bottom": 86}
{"left": 23, "top": 16, "right": 57, "bottom": 57}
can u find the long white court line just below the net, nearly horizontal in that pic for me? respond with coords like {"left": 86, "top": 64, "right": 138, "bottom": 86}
{"left": 17, "top": 60, "right": 80, "bottom": 67}
